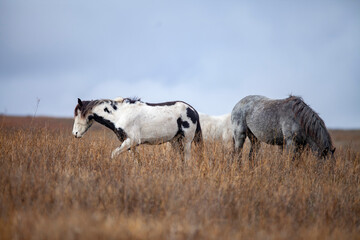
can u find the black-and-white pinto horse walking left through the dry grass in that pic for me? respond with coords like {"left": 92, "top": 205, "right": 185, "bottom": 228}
{"left": 72, "top": 97, "right": 202, "bottom": 161}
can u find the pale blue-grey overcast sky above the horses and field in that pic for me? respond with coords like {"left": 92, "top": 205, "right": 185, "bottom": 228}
{"left": 0, "top": 0, "right": 360, "bottom": 128}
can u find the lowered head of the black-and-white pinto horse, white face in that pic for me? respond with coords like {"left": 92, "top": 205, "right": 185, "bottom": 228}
{"left": 73, "top": 98, "right": 94, "bottom": 138}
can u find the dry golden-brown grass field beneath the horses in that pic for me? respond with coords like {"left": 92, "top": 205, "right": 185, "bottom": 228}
{"left": 0, "top": 116, "right": 360, "bottom": 239}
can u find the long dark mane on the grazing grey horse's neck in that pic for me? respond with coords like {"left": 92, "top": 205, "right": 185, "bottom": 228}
{"left": 285, "top": 95, "right": 333, "bottom": 148}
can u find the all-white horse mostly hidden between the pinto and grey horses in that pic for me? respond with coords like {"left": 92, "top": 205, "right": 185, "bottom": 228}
{"left": 199, "top": 113, "right": 233, "bottom": 143}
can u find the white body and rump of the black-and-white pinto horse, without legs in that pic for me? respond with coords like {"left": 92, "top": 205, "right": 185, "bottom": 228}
{"left": 117, "top": 101, "right": 201, "bottom": 144}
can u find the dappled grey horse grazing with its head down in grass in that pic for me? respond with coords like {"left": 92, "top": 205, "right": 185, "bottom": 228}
{"left": 231, "top": 95, "right": 335, "bottom": 165}
